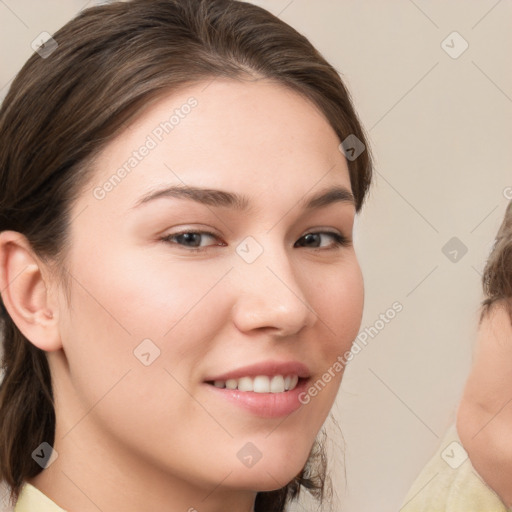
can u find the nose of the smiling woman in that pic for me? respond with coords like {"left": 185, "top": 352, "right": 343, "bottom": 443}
{"left": 231, "top": 238, "right": 317, "bottom": 337}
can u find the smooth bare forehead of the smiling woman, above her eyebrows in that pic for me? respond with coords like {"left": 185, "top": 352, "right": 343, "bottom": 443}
{"left": 77, "top": 78, "right": 350, "bottom": 216}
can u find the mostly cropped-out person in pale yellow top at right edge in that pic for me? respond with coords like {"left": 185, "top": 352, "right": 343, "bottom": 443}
{"left": 400, "top": 202, "right": 512, "bottom": 512}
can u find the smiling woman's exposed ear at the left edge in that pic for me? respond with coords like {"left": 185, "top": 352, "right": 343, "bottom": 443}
{"left": 0, "top": 231, "right": 62, "bottom": 352}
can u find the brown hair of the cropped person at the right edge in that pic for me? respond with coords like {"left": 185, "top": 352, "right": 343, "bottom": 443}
{"left": 480, "top": 201, "right": 512, "bottom": 323}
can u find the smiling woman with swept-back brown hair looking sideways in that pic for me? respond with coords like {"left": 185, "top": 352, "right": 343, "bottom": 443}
{"left": 0, "top": 0, "right": 371, "bottom": 512}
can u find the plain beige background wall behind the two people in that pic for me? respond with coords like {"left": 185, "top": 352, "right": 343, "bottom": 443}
{"left": 0, "top": 0, "right": 512, "bottom": 512}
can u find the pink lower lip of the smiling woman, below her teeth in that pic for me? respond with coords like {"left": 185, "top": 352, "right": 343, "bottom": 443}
{"left": 205, "top": 379, "right": 309, "bottom": 418}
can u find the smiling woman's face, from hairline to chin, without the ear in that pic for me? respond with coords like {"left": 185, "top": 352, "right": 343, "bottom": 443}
{"left": 49, "top": 79, "right": 363, "bottom": 496}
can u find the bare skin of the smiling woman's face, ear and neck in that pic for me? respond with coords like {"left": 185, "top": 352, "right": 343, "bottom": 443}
{"left": 0, "top": 79, "right": 364, "bottom": 512}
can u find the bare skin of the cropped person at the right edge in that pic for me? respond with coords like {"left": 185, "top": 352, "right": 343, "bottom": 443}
{"left": 457, "top": 303, "right": 512, "bottom": 507}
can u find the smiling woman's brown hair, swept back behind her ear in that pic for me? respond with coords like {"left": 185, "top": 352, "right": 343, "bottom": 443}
{"left": 0, "top": 0, "right": 372, "bottom": 512}
